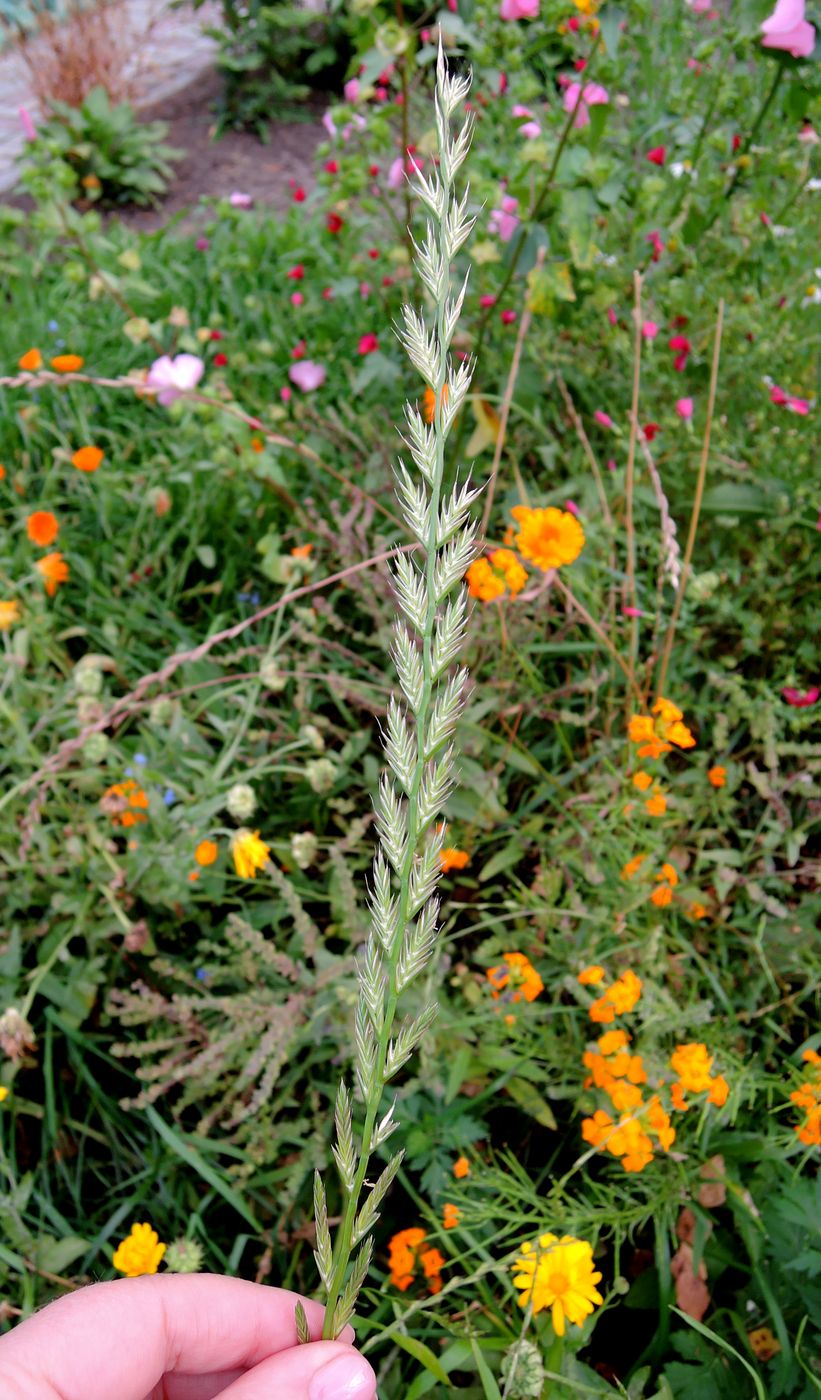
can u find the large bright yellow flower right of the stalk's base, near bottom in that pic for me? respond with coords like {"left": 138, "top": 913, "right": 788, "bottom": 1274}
{"left": 513, "top": 1235, "right": 604, "bottom": 1337}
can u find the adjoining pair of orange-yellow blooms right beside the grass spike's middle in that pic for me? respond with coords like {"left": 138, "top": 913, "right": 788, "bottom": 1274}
{"left": 465, "top": 505, "right": 584, "bottom": 603}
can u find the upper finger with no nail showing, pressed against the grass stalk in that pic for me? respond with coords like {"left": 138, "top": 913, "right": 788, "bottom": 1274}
{"left": 0, "top": 1274, "right": 344, "bottom": 1400}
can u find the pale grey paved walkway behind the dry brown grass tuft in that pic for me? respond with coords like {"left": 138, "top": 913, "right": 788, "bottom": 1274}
{"left": 0, "top": 0, "right": 220, "bottom": 195}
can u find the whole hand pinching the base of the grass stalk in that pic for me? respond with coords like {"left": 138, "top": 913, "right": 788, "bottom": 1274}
{"left": 0, "top": 1274, "right": 375, "bottom": 1400}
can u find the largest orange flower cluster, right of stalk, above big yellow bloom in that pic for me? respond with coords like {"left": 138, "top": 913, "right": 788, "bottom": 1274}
{"left": 579, "top": 963, "right": 730, "bottom": 1172}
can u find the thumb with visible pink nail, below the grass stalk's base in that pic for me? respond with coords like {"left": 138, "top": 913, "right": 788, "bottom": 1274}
{"left": 214, "top": 1341, "right": 377, "bottom": 1400}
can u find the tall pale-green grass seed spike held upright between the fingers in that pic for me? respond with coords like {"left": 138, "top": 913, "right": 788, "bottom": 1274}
{"left": 314, "top": 49, "right": 479, "bottom": 1337}
